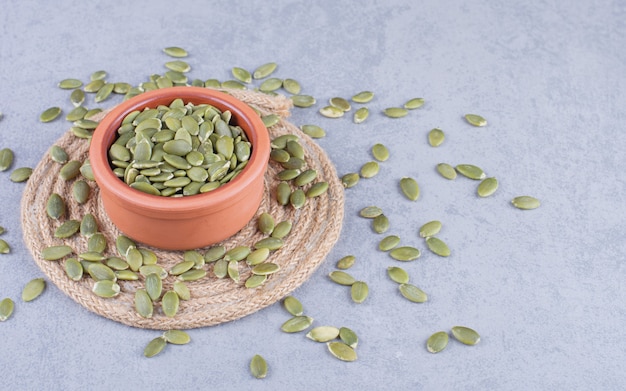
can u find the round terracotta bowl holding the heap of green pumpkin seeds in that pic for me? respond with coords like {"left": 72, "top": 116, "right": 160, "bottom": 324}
{"left": 89, "top": 87, "right": 270, "bottom": 250}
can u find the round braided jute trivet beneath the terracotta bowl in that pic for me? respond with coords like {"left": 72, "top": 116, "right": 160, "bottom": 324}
{"left": 21, "top": 91, "right": 344, "bottom": 330}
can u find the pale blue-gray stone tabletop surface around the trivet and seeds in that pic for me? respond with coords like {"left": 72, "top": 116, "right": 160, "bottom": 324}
{"left": 0, "top": 0, "right": 626, "bottom": 390}
